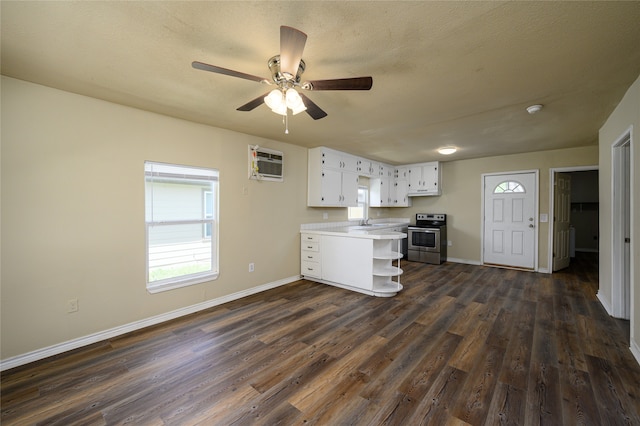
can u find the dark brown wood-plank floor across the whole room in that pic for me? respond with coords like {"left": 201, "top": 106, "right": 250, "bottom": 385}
{"left": 0, "top": 255, "right": 640, "bottom": 425}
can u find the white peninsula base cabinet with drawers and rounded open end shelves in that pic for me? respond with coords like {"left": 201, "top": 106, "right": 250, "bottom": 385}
{"left": 300, "top": 234, "right": 402, "bottom": 297}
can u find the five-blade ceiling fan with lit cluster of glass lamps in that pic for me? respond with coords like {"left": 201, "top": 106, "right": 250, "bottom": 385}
{"left": 191, "top": 25, "right": 373, "bottom": 133}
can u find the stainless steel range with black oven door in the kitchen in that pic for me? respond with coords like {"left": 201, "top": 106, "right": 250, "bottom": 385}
{"left": 407, "top": 213, "right": 447, "bottom": 265}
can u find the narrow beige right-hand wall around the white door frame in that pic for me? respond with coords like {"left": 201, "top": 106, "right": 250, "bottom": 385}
{"left": 598, "top": 77, "right": 640, "bottom": 356}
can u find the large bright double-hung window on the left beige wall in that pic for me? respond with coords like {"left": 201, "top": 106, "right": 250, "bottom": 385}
{"left": 144, "top": 162, "right": 218, "bottom": 293}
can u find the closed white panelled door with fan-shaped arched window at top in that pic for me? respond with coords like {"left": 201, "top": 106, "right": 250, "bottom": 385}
{"left": 483, "top": 172, "right": 538, "bottom": 270}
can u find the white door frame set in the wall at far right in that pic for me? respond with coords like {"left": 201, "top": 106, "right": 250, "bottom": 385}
{"left": 611, "top": 126, "right": 635, "bottom": 322}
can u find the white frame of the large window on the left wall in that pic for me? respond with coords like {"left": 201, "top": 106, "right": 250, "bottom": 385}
{"left": 144, "top": 161, "right": 220, "bottom": 294}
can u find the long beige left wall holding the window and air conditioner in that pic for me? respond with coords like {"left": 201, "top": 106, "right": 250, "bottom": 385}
{"left": 0, "top": 77, "right": 322, "bottom": 359}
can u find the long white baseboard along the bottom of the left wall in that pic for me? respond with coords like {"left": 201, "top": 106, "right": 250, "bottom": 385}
{"left": 0, "top": 275, "right": 300, "bottom": 371}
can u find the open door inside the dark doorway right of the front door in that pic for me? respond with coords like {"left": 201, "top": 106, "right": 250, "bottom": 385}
{"left": 553, "top": 173, "right": 571, "bottom": 271}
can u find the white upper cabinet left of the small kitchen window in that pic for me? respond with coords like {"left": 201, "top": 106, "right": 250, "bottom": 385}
{"left": 307, "top": 147, "right": 358, "bottom": 207}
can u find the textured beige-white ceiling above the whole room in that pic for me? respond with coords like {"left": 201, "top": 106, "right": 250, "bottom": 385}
{"left": 0, "top": 0, "right": 640, "bottom": 164}
